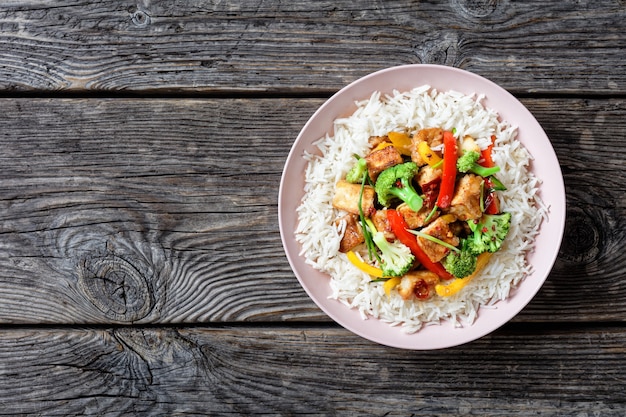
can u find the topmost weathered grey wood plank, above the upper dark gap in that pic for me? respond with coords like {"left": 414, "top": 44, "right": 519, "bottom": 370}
{"left": 0, "top": 0, "right": 626, "bottom": 94}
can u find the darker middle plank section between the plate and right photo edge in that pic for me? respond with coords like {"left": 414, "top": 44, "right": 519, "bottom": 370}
{"left": 524, "top": 100, "right": 626, "bottom": 321}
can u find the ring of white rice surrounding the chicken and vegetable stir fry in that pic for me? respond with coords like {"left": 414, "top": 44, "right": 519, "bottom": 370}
{"left": 296, "top": 86, "right": 547, "bottom": 333}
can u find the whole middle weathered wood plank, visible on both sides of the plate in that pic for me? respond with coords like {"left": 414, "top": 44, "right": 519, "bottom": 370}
{"left": 0, "top": 99, "right": 626, "bottom": 323}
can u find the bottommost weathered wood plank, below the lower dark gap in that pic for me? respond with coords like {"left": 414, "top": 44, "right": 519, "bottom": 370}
{"left": 0, "top": 326, "right": 626, "bottom": 416}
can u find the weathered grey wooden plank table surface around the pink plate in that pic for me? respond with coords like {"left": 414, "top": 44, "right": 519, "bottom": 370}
{"left": 0, "top": 0, "right": 626, "bottom": 416}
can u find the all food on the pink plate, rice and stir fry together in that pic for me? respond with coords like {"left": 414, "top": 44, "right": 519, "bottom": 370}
{"left": 296, "top": 86, "right": 546, "bottom": 332}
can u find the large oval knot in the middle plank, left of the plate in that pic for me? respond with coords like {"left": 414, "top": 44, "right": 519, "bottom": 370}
{"left": 78, "top": 255, "right": 154, "bottom": 323}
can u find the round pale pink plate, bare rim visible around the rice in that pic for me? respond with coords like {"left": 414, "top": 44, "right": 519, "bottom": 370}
{"left": 278, "top": 64, "right": 565, "bottom": 350}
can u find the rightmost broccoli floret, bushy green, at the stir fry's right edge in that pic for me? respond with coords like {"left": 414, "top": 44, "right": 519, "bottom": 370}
{"left": 467, "top": 213, "right": 511, "bottom": 254}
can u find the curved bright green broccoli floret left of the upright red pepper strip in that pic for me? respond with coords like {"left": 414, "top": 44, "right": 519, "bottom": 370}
{"left": 374, "top": 162, "right": 424, "bottom": 211}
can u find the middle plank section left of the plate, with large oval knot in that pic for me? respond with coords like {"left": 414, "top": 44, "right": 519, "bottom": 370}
{"left": 0, "top": 99, "right": 320, "bottom": 323}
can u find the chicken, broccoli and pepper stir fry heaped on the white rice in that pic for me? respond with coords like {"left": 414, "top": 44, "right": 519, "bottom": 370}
{"left": 333, "top": 128, "right": 511, "bottom": 300}
